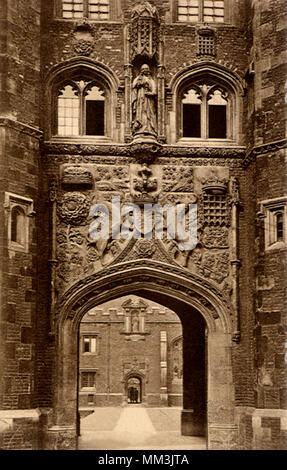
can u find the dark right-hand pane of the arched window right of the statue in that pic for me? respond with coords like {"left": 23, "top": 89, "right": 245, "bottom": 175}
{"left": 208, "top": 90, "right": 227, "bottom": 139}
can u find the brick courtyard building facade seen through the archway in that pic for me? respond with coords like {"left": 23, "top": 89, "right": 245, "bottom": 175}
{"left": 79, "top": 298, "right": 183, "bottom": 412}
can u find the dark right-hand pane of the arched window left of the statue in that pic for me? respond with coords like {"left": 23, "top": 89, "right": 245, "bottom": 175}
{"left": 85, "top": 86, "right": 105, "bottom": 135}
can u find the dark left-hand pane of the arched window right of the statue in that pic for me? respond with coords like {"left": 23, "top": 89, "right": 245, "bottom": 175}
{"left": 182, "top": 89, "right": 201, "bottom": 137}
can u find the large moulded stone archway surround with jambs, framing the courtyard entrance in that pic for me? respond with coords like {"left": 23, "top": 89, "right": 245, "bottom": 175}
{"left": 47, "top": 259, "right": 236, "bottom": 449}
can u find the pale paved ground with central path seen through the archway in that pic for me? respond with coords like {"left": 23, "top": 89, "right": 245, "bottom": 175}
{"left": 79, "top": 405, "right": 206, "bottom": 450}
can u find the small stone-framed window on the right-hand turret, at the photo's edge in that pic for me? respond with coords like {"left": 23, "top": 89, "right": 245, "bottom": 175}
{"left": 259, "top": 197, "right": 287, "bottom": 250}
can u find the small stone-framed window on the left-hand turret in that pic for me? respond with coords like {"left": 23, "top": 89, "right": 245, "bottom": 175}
{"left": 5, "top": 193, "right": 34, "bottom": 253}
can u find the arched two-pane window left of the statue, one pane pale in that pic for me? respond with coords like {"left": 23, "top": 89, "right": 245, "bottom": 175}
{"left": 57, "top": 80, "right": 105, "bottom": 137}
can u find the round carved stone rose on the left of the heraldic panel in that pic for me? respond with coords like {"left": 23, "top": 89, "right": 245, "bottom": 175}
{"left": 58, "top": 192, "right": 89, "bottom": 225}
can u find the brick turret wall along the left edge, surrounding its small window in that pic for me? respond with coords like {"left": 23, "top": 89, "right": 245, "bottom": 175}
{"left": 0, "top": 1, "right": 41, "bottom": 449}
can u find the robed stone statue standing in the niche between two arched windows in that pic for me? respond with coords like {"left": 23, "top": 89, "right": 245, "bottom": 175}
{"left": 132, "top": 64, "right": 157, "bottom": 137}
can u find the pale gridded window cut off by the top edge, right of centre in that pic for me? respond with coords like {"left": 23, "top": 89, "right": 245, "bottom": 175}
{"left": 177, "top": 0, "right": 224, "bottom": 23}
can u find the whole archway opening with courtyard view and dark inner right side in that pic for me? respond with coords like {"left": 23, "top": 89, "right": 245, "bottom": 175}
{"left": 78, "top": 293, "right": 206, "bottom": 450}
